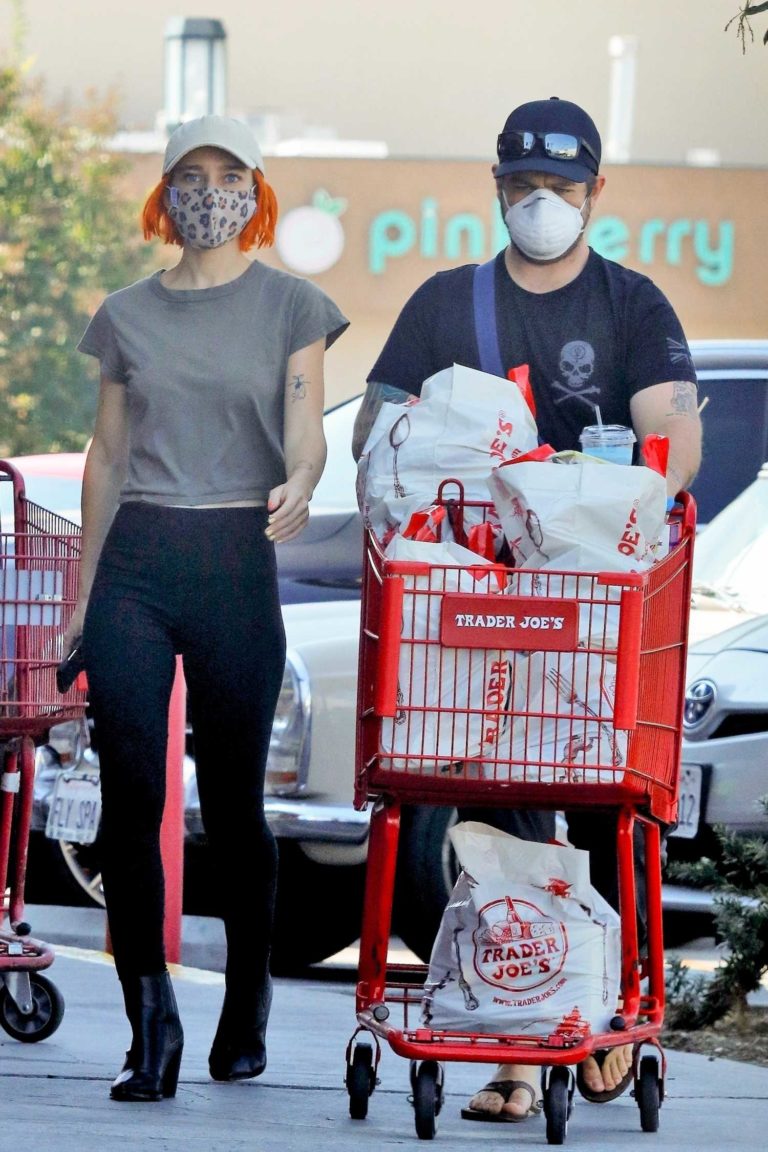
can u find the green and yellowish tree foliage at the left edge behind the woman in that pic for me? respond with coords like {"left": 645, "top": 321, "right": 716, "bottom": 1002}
{"left": 0, "top": 61, "right": 146, "bottom": 455}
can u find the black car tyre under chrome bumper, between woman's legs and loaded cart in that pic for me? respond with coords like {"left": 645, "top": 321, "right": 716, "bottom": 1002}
{"left": 271, "top": 840, "right": 365, "bottom": 975}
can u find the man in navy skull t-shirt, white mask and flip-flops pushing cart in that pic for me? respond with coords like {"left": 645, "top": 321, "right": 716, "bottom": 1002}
{"left": 352, "top": 98, "right": 701, "bottom": 1120}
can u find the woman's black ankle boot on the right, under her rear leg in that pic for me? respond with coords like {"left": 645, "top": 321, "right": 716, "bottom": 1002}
{"left": 208, "top": 976, "right": 272, "bottom": 1081}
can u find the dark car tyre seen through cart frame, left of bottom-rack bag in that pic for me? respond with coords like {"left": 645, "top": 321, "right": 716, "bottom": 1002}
{"left": 394, "top": 805, "right": 458, "bottom": 964}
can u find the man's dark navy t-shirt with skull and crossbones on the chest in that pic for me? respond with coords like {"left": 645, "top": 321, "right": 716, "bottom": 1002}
{"left": 368, "top": 251, "right": 695, "bottom": 450}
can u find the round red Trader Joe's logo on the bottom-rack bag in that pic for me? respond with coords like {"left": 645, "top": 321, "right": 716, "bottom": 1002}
{"left": 473, "top": 896, "right": 568, "bottom": 993}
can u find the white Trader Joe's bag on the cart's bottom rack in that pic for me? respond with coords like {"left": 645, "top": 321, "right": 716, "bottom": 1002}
{"left": 421, "top": 821, "right": 621, "bottom": 1036}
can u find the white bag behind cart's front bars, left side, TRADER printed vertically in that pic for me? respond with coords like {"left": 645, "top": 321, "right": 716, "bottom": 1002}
{"left": 380, "top": 536, "right": 509, "bottom": 776}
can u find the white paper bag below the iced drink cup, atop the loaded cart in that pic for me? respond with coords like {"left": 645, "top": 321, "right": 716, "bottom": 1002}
{"left": 488, "top": 453, "right": 668, "bottom": 571}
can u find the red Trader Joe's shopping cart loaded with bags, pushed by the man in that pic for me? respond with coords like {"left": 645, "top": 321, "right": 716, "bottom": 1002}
{"left": 345, "top": 482, "right": 695, "bottom": 1144}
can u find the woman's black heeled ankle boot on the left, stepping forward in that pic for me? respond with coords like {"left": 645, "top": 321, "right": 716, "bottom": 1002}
{"left": 109, "top": 972, "right": 184, "bottom": 1100}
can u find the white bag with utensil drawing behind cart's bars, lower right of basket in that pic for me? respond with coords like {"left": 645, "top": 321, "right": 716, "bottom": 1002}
{"left": 484, "top": 651, "right": 628, "bottom": 785}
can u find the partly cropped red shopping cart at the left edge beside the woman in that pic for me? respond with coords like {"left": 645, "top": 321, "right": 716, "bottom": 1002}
{"left": 0, "top": 461, "right": 85, "bottom": 1043}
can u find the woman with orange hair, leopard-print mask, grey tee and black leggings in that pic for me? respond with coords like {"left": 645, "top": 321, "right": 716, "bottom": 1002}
{"left": 64, "top": 116, "right": 348, "bottom": 1100}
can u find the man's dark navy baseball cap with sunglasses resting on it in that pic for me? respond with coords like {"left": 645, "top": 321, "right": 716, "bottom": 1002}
{"left": 496, "top": 96, "right": 602, "bottom": 183}
